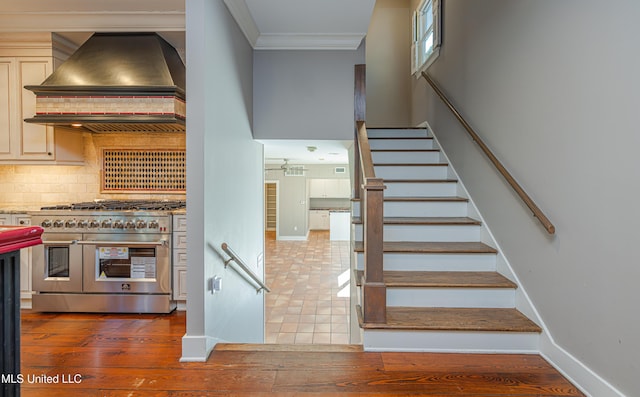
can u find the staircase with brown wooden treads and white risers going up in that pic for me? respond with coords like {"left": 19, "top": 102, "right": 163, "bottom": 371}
{"left": 353, "top": 128, "right": 541, "bottom": 353}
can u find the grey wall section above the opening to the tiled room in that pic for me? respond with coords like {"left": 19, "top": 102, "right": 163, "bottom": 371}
{"left": 253, "top": 45, "right": 365, "bottom": 140}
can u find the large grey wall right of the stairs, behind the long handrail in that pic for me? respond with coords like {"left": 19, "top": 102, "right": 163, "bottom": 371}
{"left": 412, "top": 0, "right": 640, "bottom": 396}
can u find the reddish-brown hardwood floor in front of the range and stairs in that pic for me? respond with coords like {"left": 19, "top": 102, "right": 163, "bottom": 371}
{"left": 21, "top": 311, "right": 583, "bottom": 397}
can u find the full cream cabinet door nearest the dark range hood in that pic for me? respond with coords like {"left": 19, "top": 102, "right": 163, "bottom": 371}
{"left": 17, "top": 58, "right": 54, "bottom": 160}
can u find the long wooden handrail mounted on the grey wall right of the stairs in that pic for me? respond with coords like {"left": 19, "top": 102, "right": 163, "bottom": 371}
{"left": 422, "top": 72, "right": 556, "bottom": 234}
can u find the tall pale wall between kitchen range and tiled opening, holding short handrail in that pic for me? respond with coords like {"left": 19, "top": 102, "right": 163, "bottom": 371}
{"left": 182, "top": 0, "right": 264, "bottom": 360}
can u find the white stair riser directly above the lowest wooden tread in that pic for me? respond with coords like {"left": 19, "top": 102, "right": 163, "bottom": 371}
{"left": 387, "top": 287, "right": 516, "bottom": 308}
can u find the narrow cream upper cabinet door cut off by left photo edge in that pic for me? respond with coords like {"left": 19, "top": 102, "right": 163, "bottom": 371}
{"left": 0, "top": 58, "right": 16, "bottom": 158}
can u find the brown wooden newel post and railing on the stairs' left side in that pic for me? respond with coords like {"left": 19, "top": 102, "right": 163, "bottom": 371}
{"left": 354, "top": 65, "right": 387, "bottom": 324}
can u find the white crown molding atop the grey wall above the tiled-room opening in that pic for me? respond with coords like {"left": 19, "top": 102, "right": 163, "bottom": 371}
{"left": 254, "top": 33, "right": 365, "bottom": 50}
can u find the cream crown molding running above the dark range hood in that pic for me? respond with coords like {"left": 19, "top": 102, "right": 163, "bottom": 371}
{"left": 0, "top": 11, "right": 185, "bottom": 32}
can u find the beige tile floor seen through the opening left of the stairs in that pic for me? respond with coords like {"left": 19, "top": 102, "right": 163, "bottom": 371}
{"left": 265, "top": 231, "right": 350, "bottom": 344}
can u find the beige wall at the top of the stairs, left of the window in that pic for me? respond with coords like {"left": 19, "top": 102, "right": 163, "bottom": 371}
{"left": 366, "top": 0, "right": 411, "bottom": 127}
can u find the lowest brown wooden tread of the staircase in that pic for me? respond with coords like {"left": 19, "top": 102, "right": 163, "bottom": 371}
{"left": 358, "top": 306, "right": 542, "bottom": 333}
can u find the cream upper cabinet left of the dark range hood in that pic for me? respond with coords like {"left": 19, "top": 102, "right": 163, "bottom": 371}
{"left": 0, "top": 34, "right": 84, "bottom": 164}
